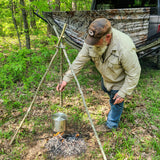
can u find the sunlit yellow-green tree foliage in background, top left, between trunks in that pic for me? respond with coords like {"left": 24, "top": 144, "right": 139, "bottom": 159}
{"left": 0, "top": 0, "right": 92, "bottom": 37}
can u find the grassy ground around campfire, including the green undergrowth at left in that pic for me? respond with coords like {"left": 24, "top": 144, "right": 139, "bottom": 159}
{"left": 0, "top": 37, "right": 160, "bottom": 160}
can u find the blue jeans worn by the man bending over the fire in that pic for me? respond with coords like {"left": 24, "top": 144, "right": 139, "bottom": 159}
{"left": 101, "top": 78, "right": 124, "bottom": 129}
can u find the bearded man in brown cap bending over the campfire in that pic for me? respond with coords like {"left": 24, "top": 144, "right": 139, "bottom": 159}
{"left": 57, "top": 18, "right": 141, "bottom": 129}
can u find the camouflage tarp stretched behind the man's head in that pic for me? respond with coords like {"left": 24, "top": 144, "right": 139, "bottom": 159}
{"left": 43, "top": 8, "right": 150, "bottom": 49}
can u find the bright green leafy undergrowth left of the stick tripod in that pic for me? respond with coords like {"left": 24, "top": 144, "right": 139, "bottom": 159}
{"left": 0, "top": 48, "right": 53, "bottom": 90}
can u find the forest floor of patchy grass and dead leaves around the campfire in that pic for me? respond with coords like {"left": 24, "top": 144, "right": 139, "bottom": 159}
{"left": 0, "top": 37, "right": 160, "bottom": 160}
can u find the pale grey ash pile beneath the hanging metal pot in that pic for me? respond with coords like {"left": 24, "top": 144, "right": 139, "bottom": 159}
{"left": 45, "top": 134, "right": 86, "bottom": 159}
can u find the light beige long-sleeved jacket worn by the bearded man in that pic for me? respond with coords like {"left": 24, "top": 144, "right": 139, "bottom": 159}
{"left": 63, "top": 28, "right": 141, "bottom": 98}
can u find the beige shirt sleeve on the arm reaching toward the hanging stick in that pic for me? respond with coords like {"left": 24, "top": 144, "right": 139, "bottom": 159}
{"left": 63, "top": 43, "right": 90, "bottom": 83}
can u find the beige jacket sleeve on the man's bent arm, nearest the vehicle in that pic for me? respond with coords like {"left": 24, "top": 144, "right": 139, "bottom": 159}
{"left": 118, "top": 48, "right": 141, "bottom": 98}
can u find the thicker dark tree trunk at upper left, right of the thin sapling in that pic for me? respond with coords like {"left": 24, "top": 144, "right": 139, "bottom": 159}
{"left": 20, "top": 0, "right": 31, "bottom": 49}
